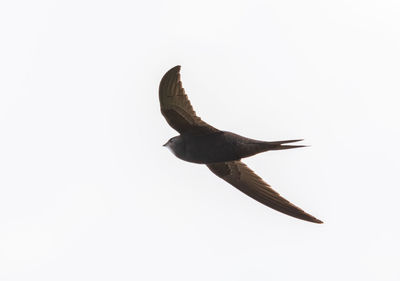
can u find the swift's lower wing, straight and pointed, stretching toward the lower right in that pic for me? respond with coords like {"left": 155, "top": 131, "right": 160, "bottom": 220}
{"left": 207, "top": 161, "right": 322, "bottom": 223}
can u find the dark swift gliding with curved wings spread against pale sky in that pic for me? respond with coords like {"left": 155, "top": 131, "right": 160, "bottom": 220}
{"left": 159, "top": 65, "right": 323, "bottom": 224}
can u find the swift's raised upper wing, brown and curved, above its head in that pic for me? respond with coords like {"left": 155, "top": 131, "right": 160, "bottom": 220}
{"left": 159, "top": 65, "right": 219, "bottom": 135}
